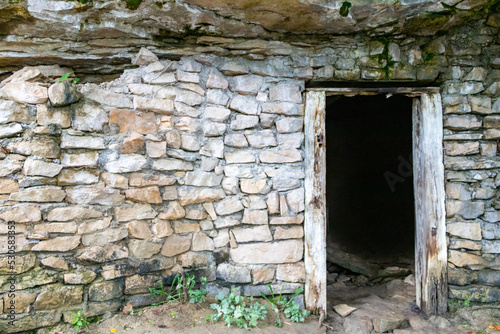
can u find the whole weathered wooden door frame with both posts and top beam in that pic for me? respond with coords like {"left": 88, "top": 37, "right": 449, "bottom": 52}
{"left": 304, "top": 87, "right": 448, "bottom": 314}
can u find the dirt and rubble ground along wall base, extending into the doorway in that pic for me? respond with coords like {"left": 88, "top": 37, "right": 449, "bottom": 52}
{"left": 38, "top": 273, "right": 500, "bottom": 334}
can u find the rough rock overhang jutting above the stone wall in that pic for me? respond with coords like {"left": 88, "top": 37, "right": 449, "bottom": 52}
{"left": 0, "top": 0, "right": 498, "bottom": 73}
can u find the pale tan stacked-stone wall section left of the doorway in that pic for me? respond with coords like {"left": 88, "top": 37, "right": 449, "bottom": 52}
{"left": 0, "top": 51, "right": 305, "bottom": 332}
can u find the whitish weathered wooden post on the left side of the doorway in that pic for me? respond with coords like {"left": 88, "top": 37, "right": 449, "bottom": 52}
{"left": 304, "top": 91, "right": 326, "bottom": 315}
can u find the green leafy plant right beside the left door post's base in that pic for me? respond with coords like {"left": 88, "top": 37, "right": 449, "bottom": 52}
{"left": 260, "top": 284, "right": 309, "bottom": 327}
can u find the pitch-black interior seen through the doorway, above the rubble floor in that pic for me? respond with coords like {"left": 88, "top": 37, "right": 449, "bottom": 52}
{"left": 326, "top": 94, "right": 415, "bottom": 262}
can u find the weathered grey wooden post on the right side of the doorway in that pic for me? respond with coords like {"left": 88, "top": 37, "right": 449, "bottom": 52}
{"left": 413, "top": 94, "right": 448, "bottom": 314}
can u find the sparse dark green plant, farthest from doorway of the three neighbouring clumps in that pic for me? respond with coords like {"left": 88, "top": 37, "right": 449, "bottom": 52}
{"left": 149, "top": 274, "right": 207, "bottom": 306}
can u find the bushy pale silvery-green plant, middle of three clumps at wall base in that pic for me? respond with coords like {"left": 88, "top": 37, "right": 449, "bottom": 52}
{"left": 205, "top": 288, "right": 267, "bottom": 329}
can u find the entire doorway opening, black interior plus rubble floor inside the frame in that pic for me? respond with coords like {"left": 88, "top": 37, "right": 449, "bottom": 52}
{"left": 325, "top": 94, "right": 416, "bottom": 320}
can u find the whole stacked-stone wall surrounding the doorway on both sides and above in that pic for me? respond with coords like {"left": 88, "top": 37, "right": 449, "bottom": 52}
{"left": 0, "top": 17, "right": 500, "bottom": 333}
